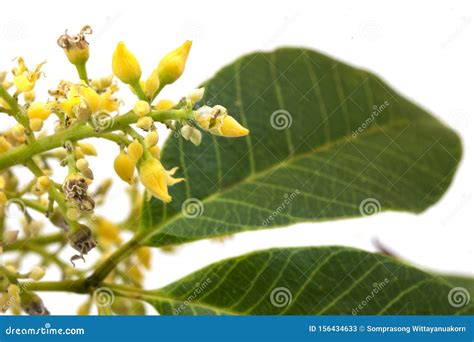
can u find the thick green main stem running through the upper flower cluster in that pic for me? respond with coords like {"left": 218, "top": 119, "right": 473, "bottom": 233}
{"left": 0, "top": 109, "right": 192, "bottom": 171}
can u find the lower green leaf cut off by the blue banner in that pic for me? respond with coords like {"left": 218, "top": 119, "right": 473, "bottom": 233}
{"left": 142, "top": 247, "right": 474, "bottom": 315}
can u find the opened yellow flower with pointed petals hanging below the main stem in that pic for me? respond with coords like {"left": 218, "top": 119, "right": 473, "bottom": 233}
{"left": 139, "top": 158, "right": 184, "bottom": 203}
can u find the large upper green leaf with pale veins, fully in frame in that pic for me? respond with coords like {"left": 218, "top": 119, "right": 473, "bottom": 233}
{"left": 142, "top": 48, "right": 461, "bottom": 246}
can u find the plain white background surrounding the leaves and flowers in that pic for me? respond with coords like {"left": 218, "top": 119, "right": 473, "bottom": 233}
{"left": 0, "top": 0, "right": 474, "bottom": 314}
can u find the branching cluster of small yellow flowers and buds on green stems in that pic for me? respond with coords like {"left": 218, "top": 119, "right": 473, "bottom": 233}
{"left": 0, "top": 26, "right": 249, "bottom": 314}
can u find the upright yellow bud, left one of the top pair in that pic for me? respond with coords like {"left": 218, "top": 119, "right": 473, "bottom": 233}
{"left": 112, "top": 42, "right": 142, "bottom": 86}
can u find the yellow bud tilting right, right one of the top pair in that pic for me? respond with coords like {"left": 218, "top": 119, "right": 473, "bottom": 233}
{"left": 157, "top": 40, "right": 192, "bottom": 86}
